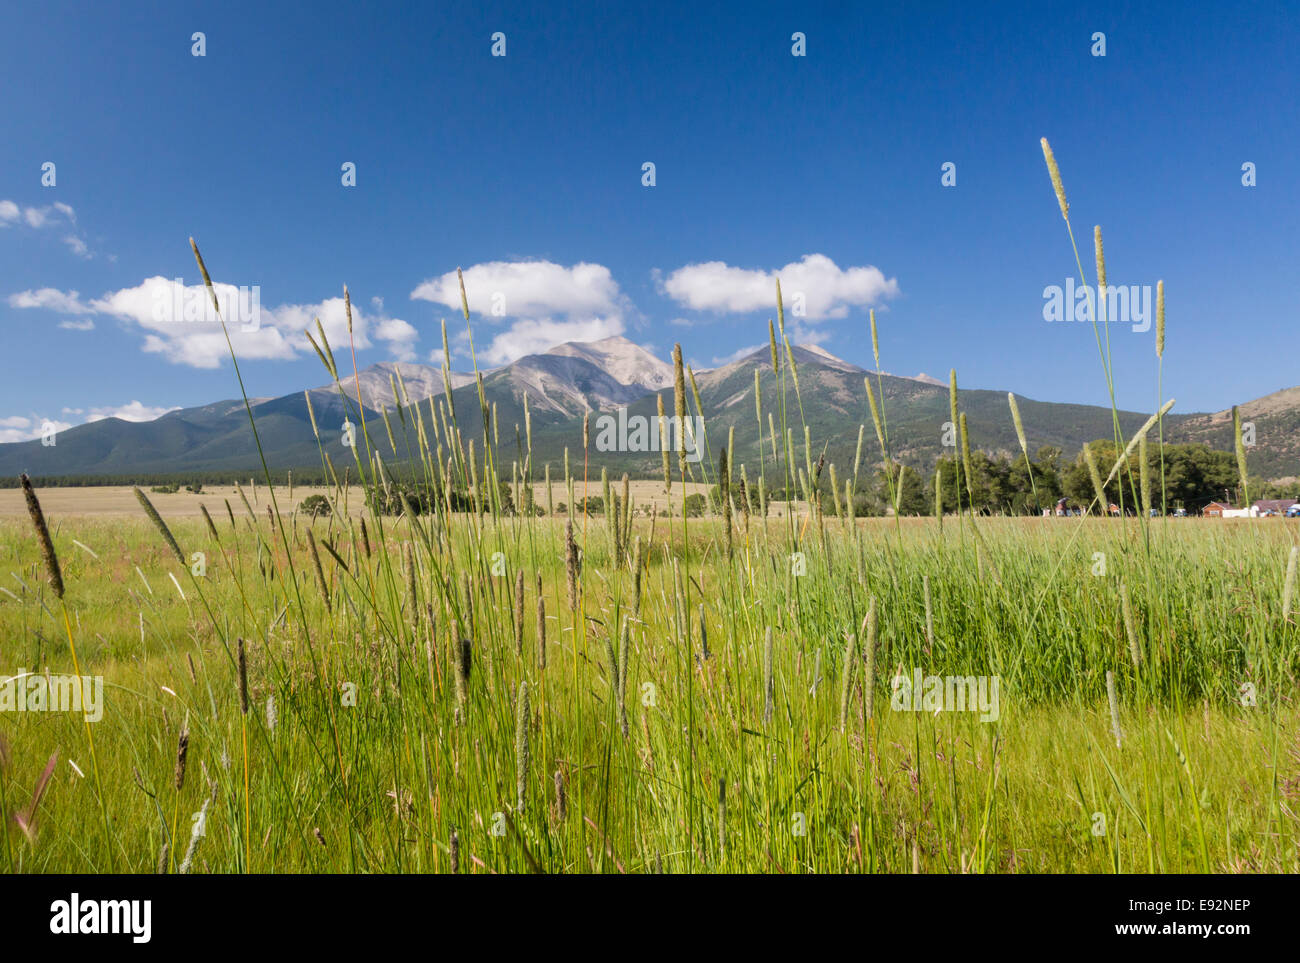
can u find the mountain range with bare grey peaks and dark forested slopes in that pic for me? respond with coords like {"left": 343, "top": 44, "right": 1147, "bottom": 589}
{"left": 0, "top": 337, "right": 1300, "bottom": 478}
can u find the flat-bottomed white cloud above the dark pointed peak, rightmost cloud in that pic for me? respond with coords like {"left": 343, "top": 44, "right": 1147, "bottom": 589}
{"left": 659, "top": 253, "right": 898, "bottom": 321}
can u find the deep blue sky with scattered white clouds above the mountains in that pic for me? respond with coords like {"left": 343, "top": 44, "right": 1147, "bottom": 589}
{"left": 0, "top": 3, "right": 1300, "bottom": 441}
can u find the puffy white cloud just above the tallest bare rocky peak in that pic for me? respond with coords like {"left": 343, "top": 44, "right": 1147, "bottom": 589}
{"left": 411, "top": 261, "right": 631, "bottom": 364}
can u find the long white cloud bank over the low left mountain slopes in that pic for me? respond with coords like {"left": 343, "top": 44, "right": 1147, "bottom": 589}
{"left": 8, "top": 277, "right": 419, "bottom": 368}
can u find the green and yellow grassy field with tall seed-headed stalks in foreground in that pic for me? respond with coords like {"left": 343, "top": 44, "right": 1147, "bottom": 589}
{"left": 0, "top": 506, "right": 1300, "bottom": 872}
